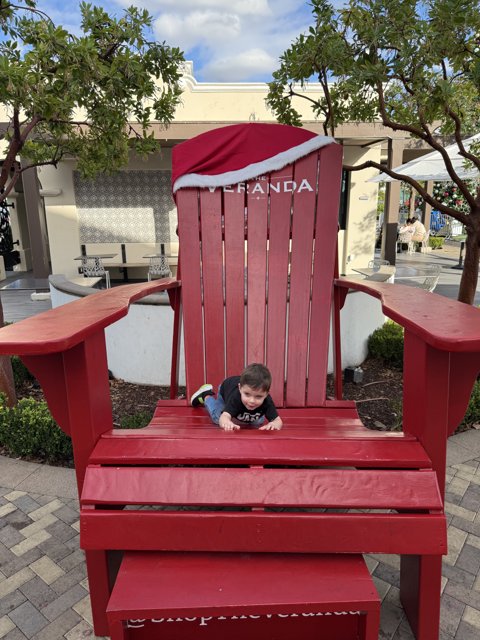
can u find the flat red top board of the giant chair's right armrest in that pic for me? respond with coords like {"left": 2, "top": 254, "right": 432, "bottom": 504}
{"left": 335, "top": 278, "right": 480, "bottom": 353}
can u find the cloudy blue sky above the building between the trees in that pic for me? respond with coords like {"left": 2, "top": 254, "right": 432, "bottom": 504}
{"left": 38, "top": 0, "right": 312, "bottom": 82}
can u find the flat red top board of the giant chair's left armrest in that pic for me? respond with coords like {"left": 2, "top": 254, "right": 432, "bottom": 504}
{"left": 0, "top": 278, "right": 181, "bottom": 356}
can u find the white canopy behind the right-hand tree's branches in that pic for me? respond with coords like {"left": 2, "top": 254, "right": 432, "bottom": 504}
{"left": 369, "top": 133, "right": 480, "bottom": 182}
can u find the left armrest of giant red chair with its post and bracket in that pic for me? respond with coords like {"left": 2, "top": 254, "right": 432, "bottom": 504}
{"left": 0, "top": 278, "right": 181, "bottom": 495}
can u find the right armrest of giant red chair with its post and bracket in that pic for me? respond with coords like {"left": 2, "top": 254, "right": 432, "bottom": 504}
{"left": 335, "top": 278, "right": 480, "bottom": 494}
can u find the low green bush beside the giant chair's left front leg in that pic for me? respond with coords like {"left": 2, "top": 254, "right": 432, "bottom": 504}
{"left": 0, "top": 394, "right": 73, "bottom": 464}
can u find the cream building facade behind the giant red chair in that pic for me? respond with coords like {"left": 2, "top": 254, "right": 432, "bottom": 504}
{"left": 0, "top": 63, "right": 420, "bottom": 279}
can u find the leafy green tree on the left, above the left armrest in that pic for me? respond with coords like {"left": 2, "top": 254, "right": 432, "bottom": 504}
{"left": 0, "top": 0, "right": 183, "bottom": 403}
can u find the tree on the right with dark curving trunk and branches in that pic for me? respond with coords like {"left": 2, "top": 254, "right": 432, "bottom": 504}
{"left": 267, "top": 0, "right": 480, "bottom": 304}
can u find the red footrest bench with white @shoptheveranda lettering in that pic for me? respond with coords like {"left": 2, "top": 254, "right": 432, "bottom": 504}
{"left": 107, "top": 552, "right": 380, "bottom": 640}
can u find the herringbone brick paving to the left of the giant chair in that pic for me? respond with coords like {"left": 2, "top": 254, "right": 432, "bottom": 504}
{"left": 0, "top": 488, "right": 107, "bottom": 640}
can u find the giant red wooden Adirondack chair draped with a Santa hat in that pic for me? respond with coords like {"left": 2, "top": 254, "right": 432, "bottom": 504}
{"left": 0, "top": 123, "right": 480, "bottom": 640}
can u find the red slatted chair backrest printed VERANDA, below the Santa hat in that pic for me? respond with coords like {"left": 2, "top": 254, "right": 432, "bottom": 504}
{"left": 177, "top": 144, "right": 342, "bottom": 407}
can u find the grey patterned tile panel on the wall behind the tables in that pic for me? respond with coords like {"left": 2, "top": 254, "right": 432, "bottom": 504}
{"left": 74, "top": 171, "right": 176, "bottom": 244}
